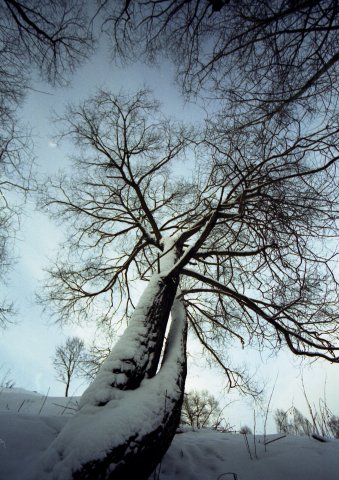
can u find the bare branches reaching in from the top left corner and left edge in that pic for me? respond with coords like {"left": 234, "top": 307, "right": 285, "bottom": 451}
{"left": 0, "top": 0, "right": 92, "bottom": 327}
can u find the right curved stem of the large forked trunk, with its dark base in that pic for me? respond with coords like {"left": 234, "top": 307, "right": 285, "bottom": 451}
{"left": 72, "top": 300, "right": 187, "bottom": 480}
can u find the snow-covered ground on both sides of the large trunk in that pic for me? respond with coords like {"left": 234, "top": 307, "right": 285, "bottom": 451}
{"left": 0, "top": 388, "right": 339, "bottom": 480}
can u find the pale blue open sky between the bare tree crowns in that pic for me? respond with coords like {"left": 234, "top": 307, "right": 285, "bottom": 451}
{"left": 0, "top": 32, "right": 339, "bottom": 428}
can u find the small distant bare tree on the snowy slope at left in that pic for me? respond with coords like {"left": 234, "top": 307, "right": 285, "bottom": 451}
{"left": 53, "top": 337, "right": 86, "bottom": 397}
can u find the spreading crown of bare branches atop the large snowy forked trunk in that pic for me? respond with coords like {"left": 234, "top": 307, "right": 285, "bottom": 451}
{"left": 44, "top": 86, "right": 338, "bottom": 386}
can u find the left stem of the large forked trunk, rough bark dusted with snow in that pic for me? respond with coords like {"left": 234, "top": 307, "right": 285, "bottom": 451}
{"left": 76, "top": 276, "right": 178, "bottom": 408}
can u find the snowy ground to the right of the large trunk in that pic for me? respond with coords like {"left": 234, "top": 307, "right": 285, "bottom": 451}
{"left": 160, "top": 429, "right": 339, "bottom": 480}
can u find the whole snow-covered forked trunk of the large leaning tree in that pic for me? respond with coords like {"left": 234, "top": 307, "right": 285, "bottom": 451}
{"left": 38, "top": 240, "right": 187, "bottom": 480}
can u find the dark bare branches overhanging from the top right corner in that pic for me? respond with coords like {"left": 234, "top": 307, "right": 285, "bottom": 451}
{"left": 107, "top": 0, "right": 339, "bottom": 124}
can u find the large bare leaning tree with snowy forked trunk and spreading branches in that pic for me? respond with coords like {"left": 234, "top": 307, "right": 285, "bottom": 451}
{"left": 35, "top": 87, "right": 339, "bottom": 479}
